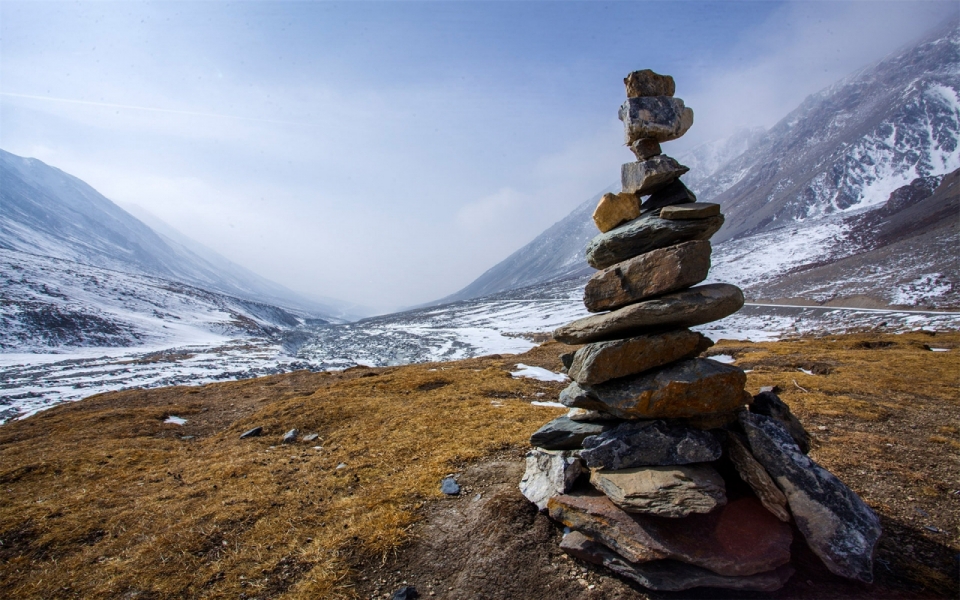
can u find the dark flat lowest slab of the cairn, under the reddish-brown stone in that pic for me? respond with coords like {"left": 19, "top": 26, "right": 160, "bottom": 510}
{"left": 560, "top": 531, "right": 794, "bottom": 592}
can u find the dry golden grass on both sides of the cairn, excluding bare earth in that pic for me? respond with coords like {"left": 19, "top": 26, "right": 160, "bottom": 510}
{"left": 0, "top": 333, "right": 960, "bottom": 598}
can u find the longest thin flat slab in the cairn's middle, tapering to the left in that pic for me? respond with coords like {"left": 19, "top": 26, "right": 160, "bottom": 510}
{"left": 553, "top": 283, "right": 743, "bottom": 344}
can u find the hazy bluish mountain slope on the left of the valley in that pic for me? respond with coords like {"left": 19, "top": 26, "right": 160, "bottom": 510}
{"left": 0, "top": 150, "right": 341, "bottom": 316}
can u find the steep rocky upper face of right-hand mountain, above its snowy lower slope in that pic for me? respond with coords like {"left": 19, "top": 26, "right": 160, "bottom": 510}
{"left": 698, "top": 22, "right": 960, "bottom": 241}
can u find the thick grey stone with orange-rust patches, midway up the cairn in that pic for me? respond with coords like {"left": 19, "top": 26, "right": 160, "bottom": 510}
{"left": 560, "top": 358, "right": 747, "bottom": 419}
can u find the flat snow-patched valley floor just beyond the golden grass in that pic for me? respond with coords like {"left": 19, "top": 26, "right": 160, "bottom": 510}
{"left": 0, "top": 280, "right": 960, "bottom": 423}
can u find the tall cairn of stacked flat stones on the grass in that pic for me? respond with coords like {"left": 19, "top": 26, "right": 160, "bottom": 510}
{"left": 520, "top": 70, "right": 880, "bottom": 591}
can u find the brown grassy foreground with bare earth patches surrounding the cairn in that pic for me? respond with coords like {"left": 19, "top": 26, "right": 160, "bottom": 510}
{"left": 0, "top": 332, "right": 960, "bottom": 600}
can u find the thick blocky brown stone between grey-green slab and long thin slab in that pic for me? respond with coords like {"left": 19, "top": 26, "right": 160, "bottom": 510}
{"left": 583, "top": 240, "right": 716, "bottom": 312}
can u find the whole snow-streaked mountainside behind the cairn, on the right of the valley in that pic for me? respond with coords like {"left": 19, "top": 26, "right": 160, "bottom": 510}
{"left": 449, "top": 21, "right": 960, "bottom": 307}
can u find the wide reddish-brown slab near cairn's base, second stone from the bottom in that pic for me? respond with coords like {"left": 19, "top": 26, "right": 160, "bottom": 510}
{"left": 547, "top": 494, "right": 793, "bottom": 576}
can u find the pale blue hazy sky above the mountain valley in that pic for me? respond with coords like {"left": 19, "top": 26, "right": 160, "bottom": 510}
{"left": 0, "top": 0, "right": 960, "bottom": 312}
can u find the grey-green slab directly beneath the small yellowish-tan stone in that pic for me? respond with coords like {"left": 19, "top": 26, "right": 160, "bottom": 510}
{"left": 586, "top": 212, "right": 723, "bottom": 269}
